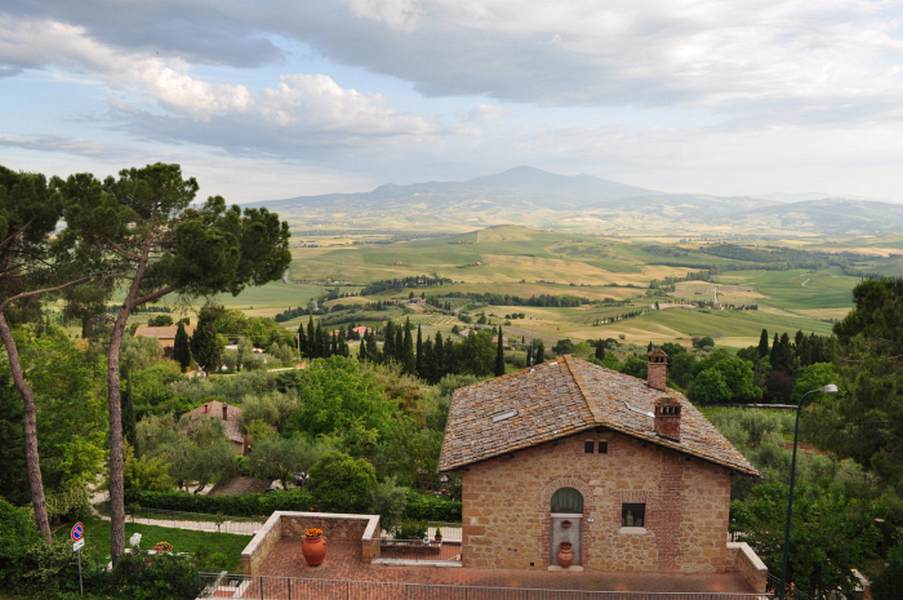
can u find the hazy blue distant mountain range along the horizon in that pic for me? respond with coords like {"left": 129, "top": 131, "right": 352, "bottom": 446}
{"left": 253, "top": 167, "right": 903, "bottom": 235}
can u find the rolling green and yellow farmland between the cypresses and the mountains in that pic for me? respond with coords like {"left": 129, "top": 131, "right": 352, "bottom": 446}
{"left": 145, "top": 226, "right": 903, "bottom": 347}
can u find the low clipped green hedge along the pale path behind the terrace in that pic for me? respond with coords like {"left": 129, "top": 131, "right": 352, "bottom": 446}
{"left": 126, "top": 490, "right": 461, "bottom": 523}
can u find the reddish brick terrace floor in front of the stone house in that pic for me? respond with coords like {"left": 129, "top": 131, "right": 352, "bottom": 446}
{"left": 258, "top": 539, "right": 753, "bottom": 592}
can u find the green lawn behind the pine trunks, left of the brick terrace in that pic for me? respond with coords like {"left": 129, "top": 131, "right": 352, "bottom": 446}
{"left": 55, "top": 518, "right": 251, "bottom": 571}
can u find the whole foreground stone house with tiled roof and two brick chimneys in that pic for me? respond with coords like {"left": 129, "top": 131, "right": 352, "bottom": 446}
{"left": 439, "top": 350, "right": 767, "bottom": 590}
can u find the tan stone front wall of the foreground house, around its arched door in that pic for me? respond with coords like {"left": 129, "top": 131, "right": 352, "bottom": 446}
{"left": 462, "top": 431, "right": 736, "bottom": 573}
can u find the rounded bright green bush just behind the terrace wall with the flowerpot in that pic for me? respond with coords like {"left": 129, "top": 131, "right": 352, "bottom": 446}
{"left": 309, "top": 451, "right": 376, "bottom": 512}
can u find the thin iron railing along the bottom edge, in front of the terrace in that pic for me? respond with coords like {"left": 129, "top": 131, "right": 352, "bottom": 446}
{"left": 198, "top": 573, "right": 773, "bottom": 600}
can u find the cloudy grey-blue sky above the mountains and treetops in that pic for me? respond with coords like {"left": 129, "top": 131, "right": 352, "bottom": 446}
{"left": 0, "top": 0, "right": 903, "bottom": 201}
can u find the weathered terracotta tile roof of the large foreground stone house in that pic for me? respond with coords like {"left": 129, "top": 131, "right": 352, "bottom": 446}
{"left": 439, "top": 356, "right": 759, "bottom": 476}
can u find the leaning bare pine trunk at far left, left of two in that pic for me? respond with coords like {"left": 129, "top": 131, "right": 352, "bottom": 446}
{"left": 0, "top": 312, "right": 53, "bottom": 544}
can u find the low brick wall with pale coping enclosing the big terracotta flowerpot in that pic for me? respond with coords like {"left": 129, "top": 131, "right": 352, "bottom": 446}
{"left": 241, "top": 511, "right": 380, "bottom": 575}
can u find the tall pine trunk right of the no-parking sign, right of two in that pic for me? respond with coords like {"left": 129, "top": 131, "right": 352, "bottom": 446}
{"left": 107, "top": 308, "right": 132, "bottom": 561}
